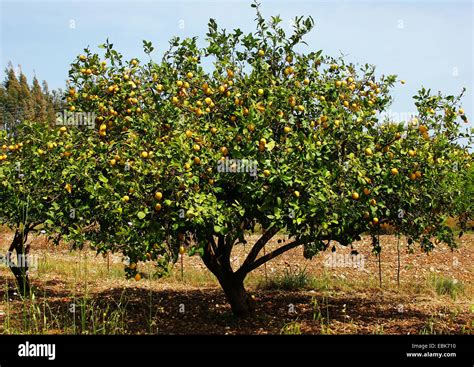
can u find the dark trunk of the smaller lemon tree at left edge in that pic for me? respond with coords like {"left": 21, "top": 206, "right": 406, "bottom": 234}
{"left": 7, "top": 230, "right": 30, "bottom": 296}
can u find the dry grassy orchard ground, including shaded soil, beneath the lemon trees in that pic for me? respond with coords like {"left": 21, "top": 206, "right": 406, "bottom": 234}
{"left": 0, "top": 231, "right": 474, "bottom": 334}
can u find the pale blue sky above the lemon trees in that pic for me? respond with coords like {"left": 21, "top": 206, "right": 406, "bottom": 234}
{"left": 0, "top": 0, "right": 474, "bottom": 126}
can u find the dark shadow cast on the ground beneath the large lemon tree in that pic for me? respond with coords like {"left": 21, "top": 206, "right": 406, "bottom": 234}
{"left": 0, "top": 280, "right": 465, "bottom": 334}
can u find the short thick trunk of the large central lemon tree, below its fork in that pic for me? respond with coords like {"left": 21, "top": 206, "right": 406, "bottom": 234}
{"left": 218, "top": 274, "right": 254, "bottom": 317}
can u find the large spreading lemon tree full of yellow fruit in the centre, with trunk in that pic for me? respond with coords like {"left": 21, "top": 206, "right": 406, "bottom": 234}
{"left": 8, "top": 4, "right": 472, "bottom": 316}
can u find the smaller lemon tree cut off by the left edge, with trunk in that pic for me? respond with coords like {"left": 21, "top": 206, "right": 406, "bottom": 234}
{"left": 0, "top": 121, "right": 95, "bottom": 294}
